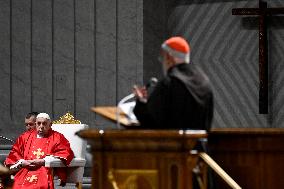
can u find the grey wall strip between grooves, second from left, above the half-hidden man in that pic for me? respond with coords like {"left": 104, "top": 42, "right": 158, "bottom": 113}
{"left": 10, "top": 0, "right": 32, "bottom": 135}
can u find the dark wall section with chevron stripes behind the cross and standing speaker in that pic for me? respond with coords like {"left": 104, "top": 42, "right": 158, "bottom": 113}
{"left": 144, "top": 0, "right": 284, "bottom": 127}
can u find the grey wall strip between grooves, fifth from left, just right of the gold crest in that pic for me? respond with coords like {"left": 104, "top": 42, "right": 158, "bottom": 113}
{"left": 74, "top": 0, "right": 96, "bottom": 127}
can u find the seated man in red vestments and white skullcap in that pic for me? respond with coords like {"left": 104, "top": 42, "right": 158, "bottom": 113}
{"left": 5, "top": 113, "right": 74, "bottom": 189}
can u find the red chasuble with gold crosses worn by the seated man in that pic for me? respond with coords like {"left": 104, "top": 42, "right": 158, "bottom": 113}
{"left": 5, "top": 130, "right": 74, "bottom": 189}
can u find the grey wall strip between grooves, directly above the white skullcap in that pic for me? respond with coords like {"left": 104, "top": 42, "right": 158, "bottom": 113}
{"left": 31, "top": 0, "right": 53, "bottom": 116}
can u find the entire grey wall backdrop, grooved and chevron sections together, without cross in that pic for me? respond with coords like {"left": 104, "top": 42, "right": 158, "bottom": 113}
{"left": 0, "top": 0, "right": 284, "bottom": 139}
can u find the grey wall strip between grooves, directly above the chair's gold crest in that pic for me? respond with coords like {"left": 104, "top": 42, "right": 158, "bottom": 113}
{"left": 52, "top": 0, "right": 75, "bottom": 118}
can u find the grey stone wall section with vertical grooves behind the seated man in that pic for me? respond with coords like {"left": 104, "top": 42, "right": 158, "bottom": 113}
{"left": 0, "top": 0, "right": 143, "bottom": 138}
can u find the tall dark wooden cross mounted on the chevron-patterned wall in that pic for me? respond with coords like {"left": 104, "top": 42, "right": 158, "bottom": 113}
{"left": 232, "top": 0, "right": 284, "bottom": 114}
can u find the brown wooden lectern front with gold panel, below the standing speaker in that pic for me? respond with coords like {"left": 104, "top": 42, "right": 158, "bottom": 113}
{"left": 77, "top": 129, "right": 207, "bottom": 189}
